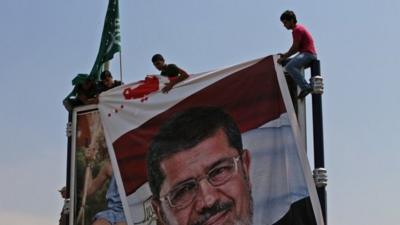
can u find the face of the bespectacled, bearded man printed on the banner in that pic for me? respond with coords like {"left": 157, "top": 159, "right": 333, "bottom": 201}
{"left": 153, "top": 129, "right": 253, "bottom": 225}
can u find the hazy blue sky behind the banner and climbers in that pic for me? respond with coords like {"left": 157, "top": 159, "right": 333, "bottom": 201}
{"left": 0, "top": 0, "right": 400, "bottom": 225}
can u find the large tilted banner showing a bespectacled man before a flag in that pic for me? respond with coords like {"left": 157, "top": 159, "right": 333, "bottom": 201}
{"left": 99, "top": 56, "right": 323, "bottom": 225}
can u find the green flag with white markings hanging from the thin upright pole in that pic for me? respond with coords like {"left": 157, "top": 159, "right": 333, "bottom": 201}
{"left": 90, "top": 0, "right": 121, "bottom": 80}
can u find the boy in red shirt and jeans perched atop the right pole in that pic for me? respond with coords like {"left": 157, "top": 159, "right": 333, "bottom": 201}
{"left": 278, "top": 10, "right": 317, "bottom": 98}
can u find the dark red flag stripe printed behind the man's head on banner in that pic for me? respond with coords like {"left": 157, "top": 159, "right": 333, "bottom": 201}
{"left": 113, "top": 56, "right": 286, "bottom": 195}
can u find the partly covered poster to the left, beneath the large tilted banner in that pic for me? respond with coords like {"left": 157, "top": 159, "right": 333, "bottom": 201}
{"left": 69, "top": 106, "right": 126, "bottom": 225}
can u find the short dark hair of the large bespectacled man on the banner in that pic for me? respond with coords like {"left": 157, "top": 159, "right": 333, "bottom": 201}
{"left": 147, "top": 106, "right": 243, "bottom": 198}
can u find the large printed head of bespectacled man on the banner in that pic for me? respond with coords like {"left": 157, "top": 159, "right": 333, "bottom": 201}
{"left": 147, "top": 107, "right": 253, "bottom": 225}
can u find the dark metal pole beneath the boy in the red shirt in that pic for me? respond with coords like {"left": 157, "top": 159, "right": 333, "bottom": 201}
{"left": 311, "top": 60, "right": 327, "bottom": 224}
